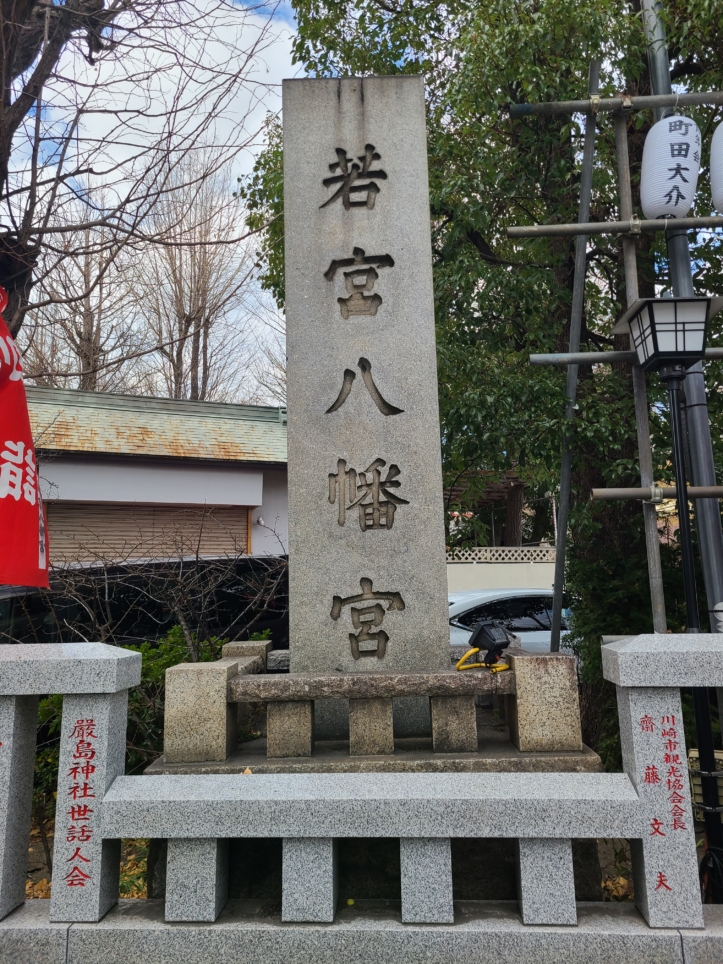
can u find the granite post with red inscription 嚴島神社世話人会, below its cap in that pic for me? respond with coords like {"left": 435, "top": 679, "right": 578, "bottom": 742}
{"left": 50, "top": 690, "right": 128, "bottom": 921}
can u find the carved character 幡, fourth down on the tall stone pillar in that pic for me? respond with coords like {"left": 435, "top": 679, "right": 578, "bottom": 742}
{"left": 329, "top": 459, "right": 409, "bottom": 532}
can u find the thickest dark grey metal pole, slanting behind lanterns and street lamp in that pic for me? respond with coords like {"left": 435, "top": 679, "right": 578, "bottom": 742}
{"left": 642, "top": 0, "right": 723, "bottom": 872}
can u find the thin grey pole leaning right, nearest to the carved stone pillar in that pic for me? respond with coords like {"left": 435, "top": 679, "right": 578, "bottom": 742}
{"left": 550, "top": 60, "right": 600, "bottom": 653}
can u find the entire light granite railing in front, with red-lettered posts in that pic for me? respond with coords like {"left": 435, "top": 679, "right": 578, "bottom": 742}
{"left": 0, "top": 635, "right": 723, "bottom": 964}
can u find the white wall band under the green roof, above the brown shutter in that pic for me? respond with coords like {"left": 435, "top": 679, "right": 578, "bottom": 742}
{"left": 40, "top": 456, "right": 264, "bottom": 506}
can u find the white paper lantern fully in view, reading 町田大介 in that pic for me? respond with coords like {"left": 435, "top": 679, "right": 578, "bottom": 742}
{"left": 640, "top": 115, "right": 700, "bottom": 220}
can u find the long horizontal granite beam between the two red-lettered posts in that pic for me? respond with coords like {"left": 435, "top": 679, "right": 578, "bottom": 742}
{"left": 102, "top": 773, "right": 649, "bottom": 838}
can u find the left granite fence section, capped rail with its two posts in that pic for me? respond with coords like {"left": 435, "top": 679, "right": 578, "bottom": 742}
{"left": 0, "top": 643, "right": 141, "bottom": 921}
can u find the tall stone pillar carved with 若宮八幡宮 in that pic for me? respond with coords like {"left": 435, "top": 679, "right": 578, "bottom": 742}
{"left": 283, "top": 77, "right": 449, "bottom": 732}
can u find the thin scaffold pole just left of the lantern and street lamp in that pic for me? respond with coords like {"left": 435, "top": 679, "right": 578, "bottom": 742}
{"left": 615, "top": 112, "right": 668, "bottom": 633}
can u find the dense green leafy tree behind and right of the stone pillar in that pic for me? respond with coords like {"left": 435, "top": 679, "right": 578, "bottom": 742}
{"left": 246, "top": 0, "right": 723, "bottom": 767}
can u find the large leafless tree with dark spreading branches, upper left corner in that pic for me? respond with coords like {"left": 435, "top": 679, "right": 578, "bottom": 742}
{"left": 0, "top": 0, "right": 282, "bottom": 340}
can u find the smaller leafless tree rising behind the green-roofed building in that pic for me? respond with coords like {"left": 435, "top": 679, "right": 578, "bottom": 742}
{"left": 133, "top": 155, "right": 262, "bottom": 401}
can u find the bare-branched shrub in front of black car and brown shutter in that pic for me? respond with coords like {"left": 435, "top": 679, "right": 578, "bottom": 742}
{"left": 7, "top": 506, "right": 288, "bottom": 661}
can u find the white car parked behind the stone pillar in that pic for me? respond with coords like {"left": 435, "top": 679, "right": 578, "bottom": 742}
{"left": 449, "top": 589, "right": 569, "bottom": 653}
